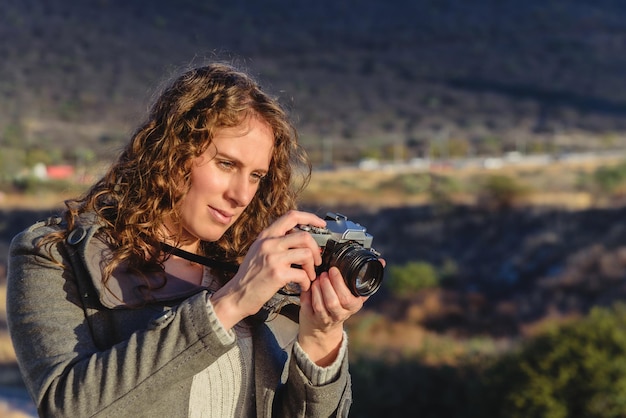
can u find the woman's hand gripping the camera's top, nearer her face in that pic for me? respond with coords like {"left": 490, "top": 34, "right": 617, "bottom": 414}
{"left": 211, "top": 210, "right": 326, "bottom": 329}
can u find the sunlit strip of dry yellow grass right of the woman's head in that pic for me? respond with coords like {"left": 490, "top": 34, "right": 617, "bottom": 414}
{"left": 302, "top": 159, "right": 621, "bottom": 209}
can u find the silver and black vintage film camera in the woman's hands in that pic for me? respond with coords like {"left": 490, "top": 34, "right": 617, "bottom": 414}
{"left": 299, "top": 212, "right": 384, "bottom": 296}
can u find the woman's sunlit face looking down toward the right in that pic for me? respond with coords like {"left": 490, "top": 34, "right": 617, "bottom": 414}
{"left": 172, "top": 117, "right": 274, "bottom": 245}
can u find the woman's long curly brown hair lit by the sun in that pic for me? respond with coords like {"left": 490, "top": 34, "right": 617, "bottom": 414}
{"left": 47, "top": 63, "right": 311, "bottom": 280}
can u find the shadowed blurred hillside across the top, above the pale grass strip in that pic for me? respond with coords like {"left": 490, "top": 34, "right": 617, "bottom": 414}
{"left": 0, "top": 0, "right": 626, "bottom": 162}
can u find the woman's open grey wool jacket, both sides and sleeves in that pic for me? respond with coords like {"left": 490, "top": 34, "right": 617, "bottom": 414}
{"left": 7, "top": 219, "right": 352, "bottom": 418}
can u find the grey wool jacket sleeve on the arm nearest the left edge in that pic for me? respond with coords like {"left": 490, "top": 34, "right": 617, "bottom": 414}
{"left": 7, "top": 226, "right": 232, "bottom": 417}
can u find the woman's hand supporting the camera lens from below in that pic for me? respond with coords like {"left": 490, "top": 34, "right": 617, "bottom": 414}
{"left": 298, "top": 267, "right": 367, "bottom": 367}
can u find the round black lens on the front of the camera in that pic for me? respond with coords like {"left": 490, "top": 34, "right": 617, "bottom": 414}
{"left": 330, "top": 243, "right": 384, "bottom": 296}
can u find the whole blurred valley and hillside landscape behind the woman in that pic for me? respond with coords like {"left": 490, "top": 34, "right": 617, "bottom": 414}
{"left": 0, "top": 0, "right": 626, "bottom": 418}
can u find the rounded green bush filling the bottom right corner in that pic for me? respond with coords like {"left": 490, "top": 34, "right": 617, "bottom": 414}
{"left": 485, "top": 304, "right": 626, "bottom": 418}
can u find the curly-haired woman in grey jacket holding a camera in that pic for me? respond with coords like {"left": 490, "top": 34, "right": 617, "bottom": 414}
{"left": 7, "top": 64, "right": 365, "bottom": 417}
